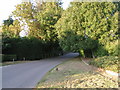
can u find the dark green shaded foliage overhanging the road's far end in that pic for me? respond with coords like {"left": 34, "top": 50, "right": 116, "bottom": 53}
{"left": 59, "top": 30, "right": 108, "bottom": 57}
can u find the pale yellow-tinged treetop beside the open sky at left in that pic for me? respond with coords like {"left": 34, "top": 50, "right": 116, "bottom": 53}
{"left": 13, "top": 2, "right": 37, "bottom": 37}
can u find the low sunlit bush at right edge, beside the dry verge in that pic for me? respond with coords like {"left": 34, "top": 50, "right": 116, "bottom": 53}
{"left": 90, "top": 56, "right": 119, "bottom": 72}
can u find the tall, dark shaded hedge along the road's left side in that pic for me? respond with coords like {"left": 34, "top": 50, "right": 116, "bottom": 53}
{"left": 2, "top": 38, "right": 62, "bottom": 60}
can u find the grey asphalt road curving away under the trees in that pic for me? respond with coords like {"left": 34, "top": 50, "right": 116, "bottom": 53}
{"left": 2, "top": 53, "right": 78, "bottom": 88}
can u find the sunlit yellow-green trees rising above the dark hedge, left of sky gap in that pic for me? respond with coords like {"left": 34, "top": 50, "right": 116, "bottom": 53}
{"left": 13, "top": 0, "right": 62, "bottom": 41}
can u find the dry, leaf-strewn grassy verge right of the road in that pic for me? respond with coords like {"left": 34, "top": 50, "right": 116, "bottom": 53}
{"left": 37, "top": 58, "right": 118, "bottom": 88}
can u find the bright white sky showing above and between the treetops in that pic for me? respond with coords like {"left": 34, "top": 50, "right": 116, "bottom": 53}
{"left": 0, "top": 0, "right": 72, "bottom": 25}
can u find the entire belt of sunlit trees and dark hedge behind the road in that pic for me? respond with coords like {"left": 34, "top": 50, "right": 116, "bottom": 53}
{"left": 2, "top": 0, "right": 120, "bottom": 59}
